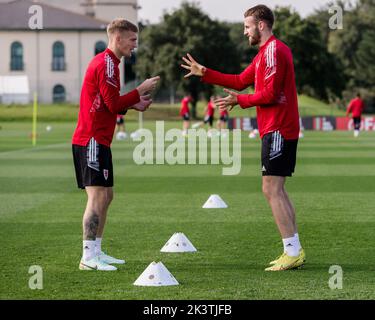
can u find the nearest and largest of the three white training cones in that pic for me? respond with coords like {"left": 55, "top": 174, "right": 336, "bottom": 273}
{"left": 133, "top": 261, "right": 178, "bottom": 287}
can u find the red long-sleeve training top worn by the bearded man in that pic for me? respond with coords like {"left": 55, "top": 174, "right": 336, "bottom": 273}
{"left": 202, "top": 36, "right": 299, "bottom": 139}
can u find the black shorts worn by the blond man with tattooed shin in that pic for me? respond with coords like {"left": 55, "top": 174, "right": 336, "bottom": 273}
{"left": 72, "top": 138, "right": 113, "bottom": 189}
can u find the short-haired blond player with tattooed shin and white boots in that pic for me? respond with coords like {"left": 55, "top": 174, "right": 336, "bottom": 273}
{"left": 72, "top": 19, "right": 159, "bottom": 271}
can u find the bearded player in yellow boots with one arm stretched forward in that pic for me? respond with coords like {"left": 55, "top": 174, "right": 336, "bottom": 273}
{"left": 181, "top": 5, "right": 305, "bottom": 271}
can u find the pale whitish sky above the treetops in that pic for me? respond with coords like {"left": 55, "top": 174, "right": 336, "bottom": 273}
{"left": 138, "top": 0, "right": 352, "bottom": 23}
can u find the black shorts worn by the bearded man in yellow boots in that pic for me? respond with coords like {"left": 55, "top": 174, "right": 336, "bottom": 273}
{"left": 262, "top": 131, "right": 298, "bottom": 177}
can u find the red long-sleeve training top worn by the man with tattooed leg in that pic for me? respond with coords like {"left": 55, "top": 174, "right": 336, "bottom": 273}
{"left": 72, "top": 48, "right": 140, "bottom": 147}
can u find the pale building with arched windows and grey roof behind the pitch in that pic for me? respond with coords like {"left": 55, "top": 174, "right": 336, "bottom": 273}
{"left": 0, "top": 0, "right": 138, "bottom": 103}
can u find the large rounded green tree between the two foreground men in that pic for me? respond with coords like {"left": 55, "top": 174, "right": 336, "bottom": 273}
{"left": 136, "top": 3, "right": 240, "bottom": 118}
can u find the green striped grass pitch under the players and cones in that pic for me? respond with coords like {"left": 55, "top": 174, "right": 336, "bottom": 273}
{"left": 0, "top": 122, "right": 375, "bottom": 300}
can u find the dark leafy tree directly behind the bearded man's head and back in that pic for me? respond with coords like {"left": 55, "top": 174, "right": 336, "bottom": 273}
{"left": 274, "top": 7, "right": 345, "bottom": 100}
